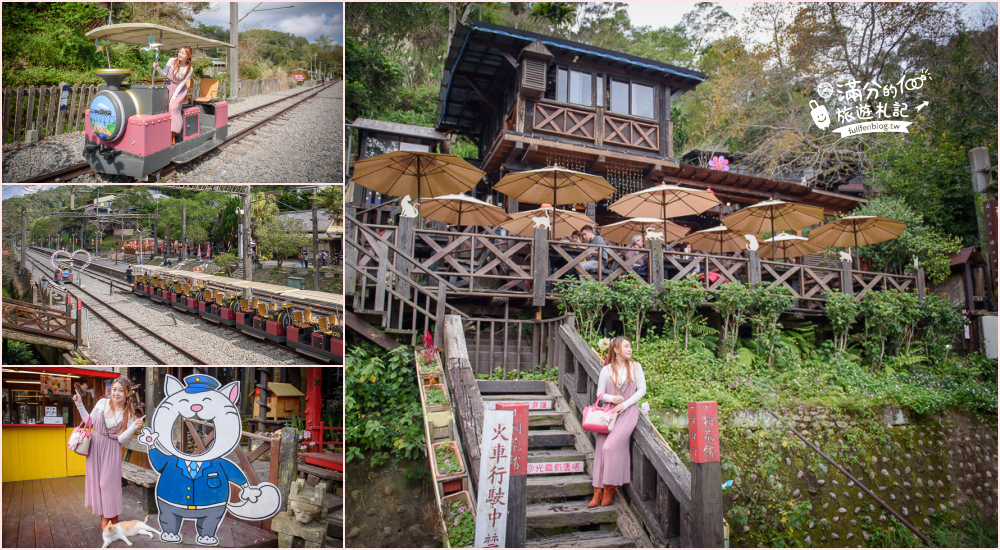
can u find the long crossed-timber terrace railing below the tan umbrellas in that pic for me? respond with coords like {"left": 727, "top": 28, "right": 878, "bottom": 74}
{"left": 345, "top": 216, "right": 925, "bottom": 318}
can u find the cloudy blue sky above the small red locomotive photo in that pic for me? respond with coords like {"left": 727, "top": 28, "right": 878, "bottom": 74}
{"left": 195, "top": 0, "right": 344, "bottom": 44}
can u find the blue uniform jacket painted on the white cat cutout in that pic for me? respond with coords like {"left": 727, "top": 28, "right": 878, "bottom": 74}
{"left": 149, "top": 449, "right": 247, "bottom": 507}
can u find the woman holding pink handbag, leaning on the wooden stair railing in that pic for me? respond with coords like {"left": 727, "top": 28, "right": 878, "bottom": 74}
{"left": 587, "top": 337, "right": 646, "bottom": 508}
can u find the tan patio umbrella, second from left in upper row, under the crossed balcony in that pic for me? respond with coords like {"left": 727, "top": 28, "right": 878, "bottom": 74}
{"left": 493, "top": 166, "right": 615, "bottom": 235}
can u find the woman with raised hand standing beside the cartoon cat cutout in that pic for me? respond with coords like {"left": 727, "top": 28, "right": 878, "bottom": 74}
{"left": 73, "top": 378, "right": 146, "bottom": 531}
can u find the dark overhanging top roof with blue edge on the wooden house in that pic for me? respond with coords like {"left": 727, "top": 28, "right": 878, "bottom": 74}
{"left": 437, "top": 21, "right": 708, "bottom": 132}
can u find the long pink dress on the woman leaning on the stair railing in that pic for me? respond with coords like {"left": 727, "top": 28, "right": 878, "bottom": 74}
{"left": 593, "top": 368, "right": 639, "bottom": 487}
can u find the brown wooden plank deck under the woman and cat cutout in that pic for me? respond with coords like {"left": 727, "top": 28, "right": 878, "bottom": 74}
{"left": 3, "top": 476, "right": 278, "bottom": 548}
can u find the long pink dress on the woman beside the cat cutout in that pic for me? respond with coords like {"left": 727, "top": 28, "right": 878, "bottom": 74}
{"left": 83, "top": 408, "right": 122, "bottom": 518}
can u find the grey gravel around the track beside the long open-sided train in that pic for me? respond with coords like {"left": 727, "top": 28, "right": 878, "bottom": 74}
{"left": 24, "top": 254, "right": 319, "bottom": 365}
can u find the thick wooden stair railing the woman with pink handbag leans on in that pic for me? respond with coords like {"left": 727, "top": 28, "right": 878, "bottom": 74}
{"left": 556, "top": 322, "right": 699, "bottom": 548}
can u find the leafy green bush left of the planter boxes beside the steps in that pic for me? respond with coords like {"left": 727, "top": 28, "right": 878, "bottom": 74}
{"left": 344, "top": 331, "right": 425, "bottom": 466}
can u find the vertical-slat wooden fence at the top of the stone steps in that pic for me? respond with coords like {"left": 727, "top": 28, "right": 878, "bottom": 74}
{"left": 465, "top": 312, "right": 567, "bottom": 375}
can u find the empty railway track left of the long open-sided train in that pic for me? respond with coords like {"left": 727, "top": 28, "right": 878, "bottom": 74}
{"left": 26, "top": 252, "right": 211, "bottom": 365}
